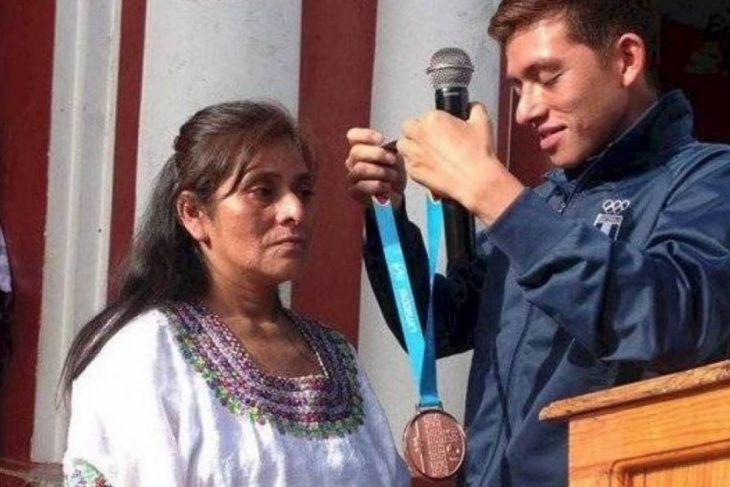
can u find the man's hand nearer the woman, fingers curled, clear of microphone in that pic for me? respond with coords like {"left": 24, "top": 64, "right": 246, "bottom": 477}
{"left": 345, "top": 128, "right": 406, "bottom": 206}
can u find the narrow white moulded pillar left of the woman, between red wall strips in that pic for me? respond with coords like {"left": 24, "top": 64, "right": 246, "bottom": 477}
{"left": 31, "top": 0, "right": 121, "bottom": 462}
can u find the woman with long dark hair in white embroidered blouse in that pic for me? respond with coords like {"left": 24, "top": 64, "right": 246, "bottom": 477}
{"left": 64, "top": 102, "right": 409, "bottom": 487}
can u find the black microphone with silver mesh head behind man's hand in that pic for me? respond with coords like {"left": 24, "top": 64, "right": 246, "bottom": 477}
{"left": 426, "top": 47, "right": 475, "bottom": 265}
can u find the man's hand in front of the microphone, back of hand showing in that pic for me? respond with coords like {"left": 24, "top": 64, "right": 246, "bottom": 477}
{"left": 397, "top": 104, "right": 524, "bottom": 224}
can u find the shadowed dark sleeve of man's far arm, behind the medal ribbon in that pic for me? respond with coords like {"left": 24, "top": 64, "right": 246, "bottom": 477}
{"left": 363, "top": 204, "right": 484, "bottom": 357}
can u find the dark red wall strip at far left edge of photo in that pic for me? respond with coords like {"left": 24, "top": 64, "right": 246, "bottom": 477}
{"left": 0, "top": 0, "right": 55, "bottom": 461}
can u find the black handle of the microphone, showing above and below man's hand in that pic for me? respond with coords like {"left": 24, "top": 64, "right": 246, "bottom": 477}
{"left": 436, "top": 86, "right": 475, "bottom": 265}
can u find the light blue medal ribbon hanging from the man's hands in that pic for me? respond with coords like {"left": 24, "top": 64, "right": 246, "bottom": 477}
{"left": 373, "top": 196, "right": 444, "bottom": 409}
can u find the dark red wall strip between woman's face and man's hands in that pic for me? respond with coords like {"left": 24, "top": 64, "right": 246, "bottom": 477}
{"left": 292, "top": 0, "right": 377, "bottom": 343}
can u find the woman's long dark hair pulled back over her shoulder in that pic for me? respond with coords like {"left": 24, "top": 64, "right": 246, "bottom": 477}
{"left": 61, "top": 101, "right": 315, "bottom": 395}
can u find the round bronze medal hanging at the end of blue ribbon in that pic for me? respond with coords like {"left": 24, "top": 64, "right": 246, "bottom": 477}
{"left": 403, "top": 409, "right": 466, "bottom": 480}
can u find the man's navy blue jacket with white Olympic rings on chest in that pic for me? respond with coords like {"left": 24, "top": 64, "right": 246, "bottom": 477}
{"left": 365, "top": 91, "right": 730, "bottom": 487}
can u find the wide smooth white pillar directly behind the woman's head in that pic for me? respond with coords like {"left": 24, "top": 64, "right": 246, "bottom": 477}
{"left": 136, "top": 0, "right": 301, "bottom": 218}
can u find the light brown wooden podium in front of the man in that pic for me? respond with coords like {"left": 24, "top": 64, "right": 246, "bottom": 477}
{"left": 540, "top": 361, "right": 730, "bottom": 487}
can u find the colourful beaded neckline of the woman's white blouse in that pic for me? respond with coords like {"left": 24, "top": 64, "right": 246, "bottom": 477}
{"left": 163, "top": 303, "right": 364, "bottom": 439}
